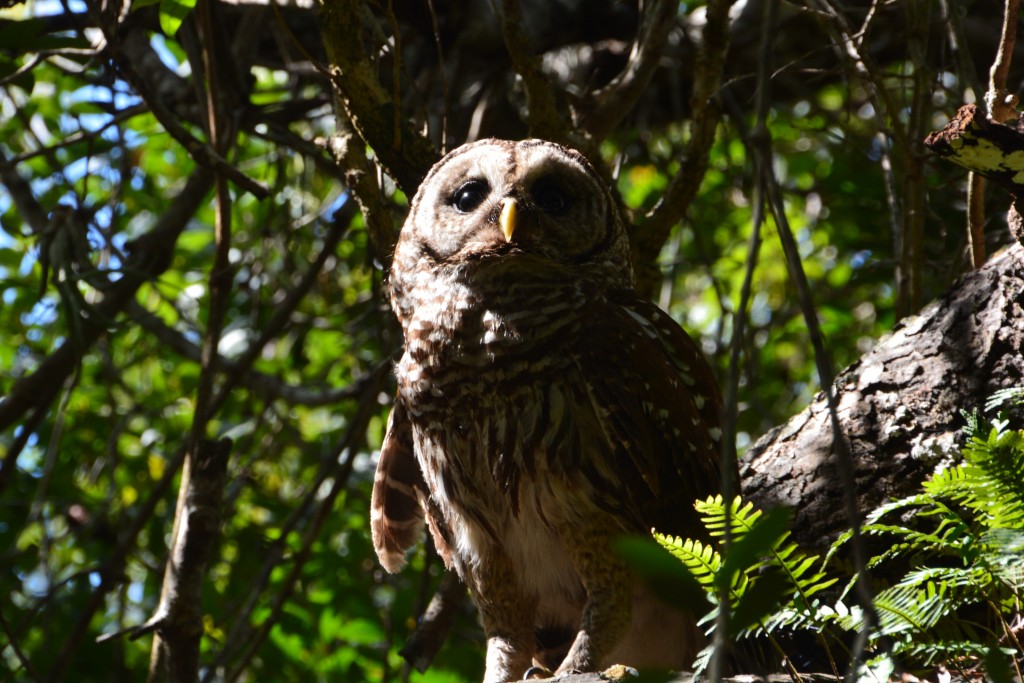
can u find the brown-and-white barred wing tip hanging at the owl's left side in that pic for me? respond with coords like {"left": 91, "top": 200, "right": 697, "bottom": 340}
{"left": 370, "top": 396, "right": 452, "bottom": 573}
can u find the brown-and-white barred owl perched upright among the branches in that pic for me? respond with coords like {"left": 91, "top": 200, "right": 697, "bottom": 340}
{"left": 371, "top": 139, "right": 720, "bottom": 683}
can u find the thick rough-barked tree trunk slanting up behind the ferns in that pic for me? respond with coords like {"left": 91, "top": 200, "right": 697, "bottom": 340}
{"left": 740, "top": 245, "right": 1024, "bottom": 547}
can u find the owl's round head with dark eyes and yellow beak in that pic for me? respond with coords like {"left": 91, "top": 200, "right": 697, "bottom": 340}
{"left": 392, "top": 139, "right": 633, "bottom": 296}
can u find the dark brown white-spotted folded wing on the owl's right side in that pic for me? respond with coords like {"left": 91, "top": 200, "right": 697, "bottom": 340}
{"left": 577, "top": 293, "right": 721, "bottom": 536}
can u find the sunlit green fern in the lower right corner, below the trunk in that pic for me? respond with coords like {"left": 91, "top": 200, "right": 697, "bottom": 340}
{"left": 829, "top": 397, "right": 1024, "bottom": 664}
